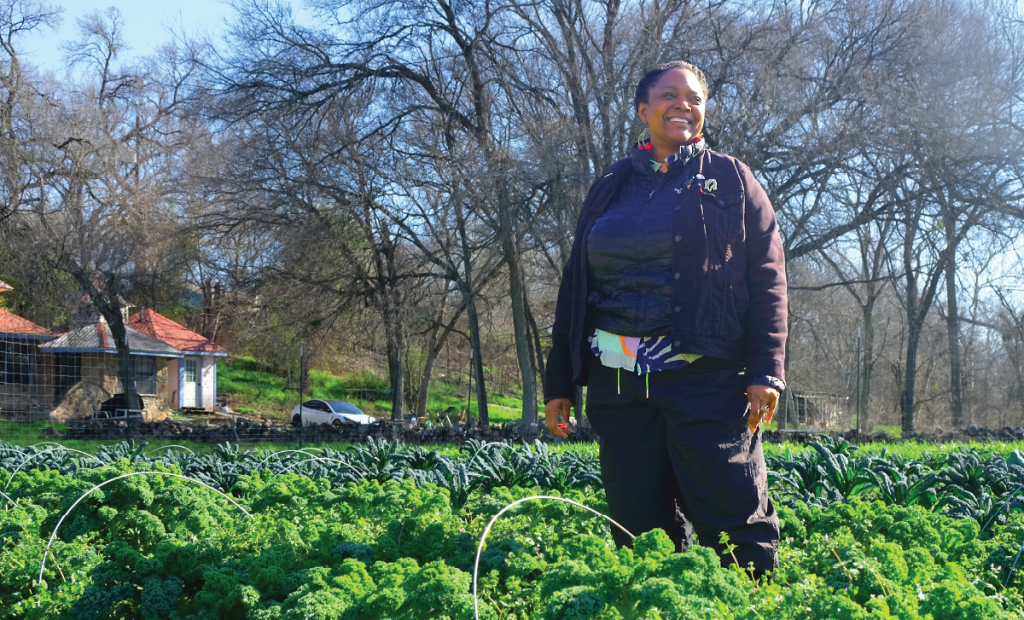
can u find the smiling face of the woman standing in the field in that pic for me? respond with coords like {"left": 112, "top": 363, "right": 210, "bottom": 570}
{"left": 637, "top": 69, "right": 705, "bottom": 155}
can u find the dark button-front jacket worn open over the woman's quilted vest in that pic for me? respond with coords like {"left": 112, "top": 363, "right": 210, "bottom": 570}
{"left": 544, "top": 151, "right": 786, "bottom": 402}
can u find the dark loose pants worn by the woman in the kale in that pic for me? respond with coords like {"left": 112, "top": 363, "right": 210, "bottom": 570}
{"left": 587, "top": 358, "right": 778, "bottom": 574}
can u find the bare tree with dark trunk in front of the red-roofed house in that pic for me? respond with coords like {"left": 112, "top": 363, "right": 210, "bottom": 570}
{"left": 15, "top": 9, "right": 205, "bottom": 403}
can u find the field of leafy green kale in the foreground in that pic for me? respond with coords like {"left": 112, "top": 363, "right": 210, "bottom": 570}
{"left": 0, "top": 439, "right": 1024, "bottom": 620}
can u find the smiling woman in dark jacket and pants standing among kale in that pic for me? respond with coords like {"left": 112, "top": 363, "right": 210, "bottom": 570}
{"left": 544, "top": 61, "right": 786, "bottom": 574}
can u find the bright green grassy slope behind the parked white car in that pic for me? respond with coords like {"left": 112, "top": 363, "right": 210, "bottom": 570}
{"left": 217, "top": 358, "right": 522, "bottom": 422}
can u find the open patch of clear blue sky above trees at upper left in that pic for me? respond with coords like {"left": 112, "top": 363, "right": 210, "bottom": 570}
{"left": 20, "top": 0, "right": 230, "bottom": 73}
